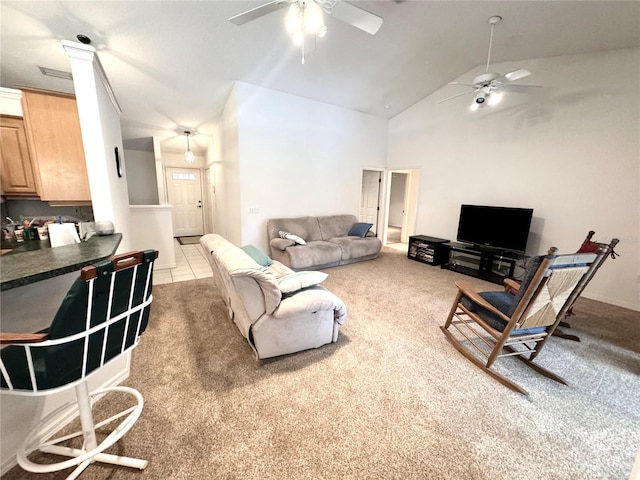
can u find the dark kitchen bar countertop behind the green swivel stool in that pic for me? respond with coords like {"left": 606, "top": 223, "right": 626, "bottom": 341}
{"left": 0, "top": 233, "right": 122, "bottom": 291}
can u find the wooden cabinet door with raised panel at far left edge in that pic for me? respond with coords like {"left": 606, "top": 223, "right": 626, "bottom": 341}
{"left": 0, "top": 115, "right": 38, "bottom": 197}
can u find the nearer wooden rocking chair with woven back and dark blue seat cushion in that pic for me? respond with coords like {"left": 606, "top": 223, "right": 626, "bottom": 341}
{"left": 440, "top": 247, "right": 605, "bottom": 395}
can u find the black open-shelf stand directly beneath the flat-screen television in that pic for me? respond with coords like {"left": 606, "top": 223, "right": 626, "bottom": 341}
{"left": 442, "top": 242, "right": 524, "bottom": 284}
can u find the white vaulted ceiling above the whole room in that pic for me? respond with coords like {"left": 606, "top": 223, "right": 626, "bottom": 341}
{"left": 0, "top": 0, "right": 640, "bottom": 152}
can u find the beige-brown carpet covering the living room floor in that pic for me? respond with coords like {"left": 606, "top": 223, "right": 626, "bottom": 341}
{"left": 6, "top": 248, "right": 640, "bottom": 480}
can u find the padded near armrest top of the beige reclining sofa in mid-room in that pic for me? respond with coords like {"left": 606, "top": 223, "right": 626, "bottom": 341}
{"left": 273, "top": 286, "right": 347, "bottom": 325}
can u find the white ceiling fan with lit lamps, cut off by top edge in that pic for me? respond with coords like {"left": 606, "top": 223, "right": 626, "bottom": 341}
{"left": 229, "top": 0, "right": 382, "bottom": 64}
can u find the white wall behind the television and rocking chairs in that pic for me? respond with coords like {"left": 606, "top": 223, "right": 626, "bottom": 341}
{"left": 388, "top": 49, "right": 640, "bottom": 310}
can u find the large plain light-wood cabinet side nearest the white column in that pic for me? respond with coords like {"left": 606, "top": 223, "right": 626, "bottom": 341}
{"left": 22, "top": 89, "right": 91, "bottom": 204}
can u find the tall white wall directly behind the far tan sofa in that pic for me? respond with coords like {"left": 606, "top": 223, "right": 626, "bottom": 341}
{"left": 232, "top": 83, "right": 388, "bottom": 251}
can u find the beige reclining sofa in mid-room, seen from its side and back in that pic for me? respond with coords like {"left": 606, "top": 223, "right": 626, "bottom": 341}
{"left": 200, "top": 234, "right": 347, "bottom": 359}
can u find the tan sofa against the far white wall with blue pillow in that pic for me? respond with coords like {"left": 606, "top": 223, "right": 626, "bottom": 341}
{"left": 267, "top": 215, "right": 382, "bottom": 270}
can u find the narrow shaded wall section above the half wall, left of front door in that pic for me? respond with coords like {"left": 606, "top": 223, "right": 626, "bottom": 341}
{"left": 124, "top": 150, "right": 160, "bottom": 205}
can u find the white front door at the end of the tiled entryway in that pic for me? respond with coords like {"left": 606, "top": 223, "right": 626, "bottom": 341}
{"left": 165, "top": 168, "right": 204, "bottom": 237}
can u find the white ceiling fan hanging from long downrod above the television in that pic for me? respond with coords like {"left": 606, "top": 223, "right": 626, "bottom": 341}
{"left": 438, "top": 16, "right": 540, "bottom": 110}
